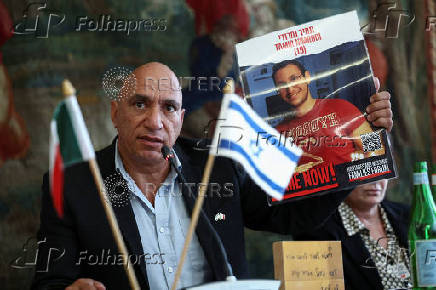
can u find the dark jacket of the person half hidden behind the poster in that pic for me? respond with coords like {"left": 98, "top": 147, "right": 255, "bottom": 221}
{"left": 295, "top": 201, "right": 409, "bottom": 290}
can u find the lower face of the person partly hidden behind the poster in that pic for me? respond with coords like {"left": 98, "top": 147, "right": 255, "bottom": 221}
{"left": 346, "top": 179, "right": 388, "bottom": 207}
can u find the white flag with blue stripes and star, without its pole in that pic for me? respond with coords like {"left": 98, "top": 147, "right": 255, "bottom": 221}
{"left": 210, "top": 94, "right": 302, "bottom": 200}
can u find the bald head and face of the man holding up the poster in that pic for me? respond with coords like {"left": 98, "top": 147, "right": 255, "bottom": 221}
{"left": 111, "top": 63, "right": 185, "bottom": 164}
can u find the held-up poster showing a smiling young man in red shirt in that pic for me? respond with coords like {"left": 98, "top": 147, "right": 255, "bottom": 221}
{"left": 236, "top": 11, "right": 396, "bottom": 204}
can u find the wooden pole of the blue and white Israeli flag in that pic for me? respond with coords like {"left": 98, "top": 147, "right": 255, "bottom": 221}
{"left": 171, "top": 80, "right": 234, "bottom": 290}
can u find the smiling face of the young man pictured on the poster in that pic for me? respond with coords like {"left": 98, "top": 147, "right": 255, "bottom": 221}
{"left": 274, "top": 64, "right": 310, "bottom": 107}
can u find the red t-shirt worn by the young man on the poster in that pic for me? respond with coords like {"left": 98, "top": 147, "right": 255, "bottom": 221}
{"left": 276, "top": 99, "right": 365, "bottom": 167}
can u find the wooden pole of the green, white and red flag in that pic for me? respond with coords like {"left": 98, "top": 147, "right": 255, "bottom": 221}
{"left": 62, "top": 80, "right": 141, "bottom": 290}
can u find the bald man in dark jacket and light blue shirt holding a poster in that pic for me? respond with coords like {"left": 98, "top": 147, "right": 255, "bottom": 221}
{"left": 29, "top": 63, "right": 392, "bottom": 290}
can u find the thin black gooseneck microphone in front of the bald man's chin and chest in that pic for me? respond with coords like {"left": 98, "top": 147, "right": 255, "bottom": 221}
{"left": 161, "top": 145, "right": 234, "bottom": 279}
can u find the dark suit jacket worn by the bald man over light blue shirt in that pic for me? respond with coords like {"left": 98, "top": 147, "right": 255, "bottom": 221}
{"left": 32, "top": 138, "right": 349, "bottom": 289}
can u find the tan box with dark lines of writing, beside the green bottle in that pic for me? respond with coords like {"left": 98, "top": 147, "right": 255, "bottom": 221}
{"left": 273, "top": 241, "right": 344, "bottom": 290}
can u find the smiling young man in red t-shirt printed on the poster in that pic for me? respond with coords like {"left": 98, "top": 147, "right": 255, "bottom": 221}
{"left": 272, "top": 60, "right": 385, "bottom": 172}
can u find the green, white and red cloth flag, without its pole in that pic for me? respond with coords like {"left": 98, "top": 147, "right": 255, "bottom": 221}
{"left": 49, "top": 95, "right": 95, "bottom": 218}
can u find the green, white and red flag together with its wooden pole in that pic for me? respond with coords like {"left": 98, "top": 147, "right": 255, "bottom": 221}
{"left": 50, "top": 80, "right": 141, "bottom": 290}
